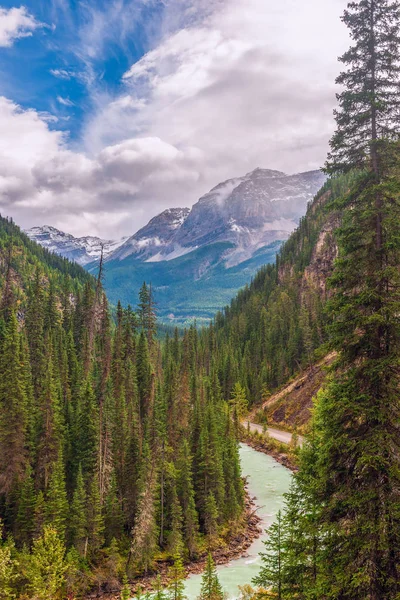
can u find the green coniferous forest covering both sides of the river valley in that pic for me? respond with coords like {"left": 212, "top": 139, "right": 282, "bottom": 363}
{"left": 0, "top": 0, "right": 400, "bottom": 600}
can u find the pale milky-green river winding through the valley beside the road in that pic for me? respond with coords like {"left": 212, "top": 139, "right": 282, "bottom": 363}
{"left": 185, "top": 444, "right": 291, "bottom": 600}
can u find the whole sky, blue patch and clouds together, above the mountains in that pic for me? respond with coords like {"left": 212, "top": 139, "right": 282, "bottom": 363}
{"left": 0, "top": 0, "right": 349, "bottom": 239}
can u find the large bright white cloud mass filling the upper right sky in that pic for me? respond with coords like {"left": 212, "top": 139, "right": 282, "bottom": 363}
{"left": 79, "top": 0, "right": 348, "bottom": 225}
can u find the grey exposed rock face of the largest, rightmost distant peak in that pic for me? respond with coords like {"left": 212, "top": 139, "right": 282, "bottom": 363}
{"left": 167, "top": 169, "right": 325, "bottom": 262}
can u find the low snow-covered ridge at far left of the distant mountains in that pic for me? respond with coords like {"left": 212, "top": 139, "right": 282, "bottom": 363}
{"left": 25, "top": 225, "right": 126, "bottom": 266}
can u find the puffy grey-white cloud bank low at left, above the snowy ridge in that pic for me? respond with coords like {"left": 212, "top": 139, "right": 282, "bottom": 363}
{"left": 0, "top": 97, "right": 199, "bottom": 236}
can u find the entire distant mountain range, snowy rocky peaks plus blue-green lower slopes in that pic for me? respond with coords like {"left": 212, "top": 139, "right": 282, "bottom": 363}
{"left": 27, "top": 169, "right": 326, "bottom": 323}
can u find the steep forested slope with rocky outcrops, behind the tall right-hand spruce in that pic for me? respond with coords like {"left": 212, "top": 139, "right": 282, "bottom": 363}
{"left": 197, "top": 171, "right": 352, "bottom": 425}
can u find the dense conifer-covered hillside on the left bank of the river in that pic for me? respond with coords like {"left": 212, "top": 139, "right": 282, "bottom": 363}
{"left": 0, "top": 214, "right": 244, "bottom": 600}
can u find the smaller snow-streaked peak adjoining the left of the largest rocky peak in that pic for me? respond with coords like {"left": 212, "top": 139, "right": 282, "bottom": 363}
{"left": 109, "top": 208, "right": 190, "bottom": 261}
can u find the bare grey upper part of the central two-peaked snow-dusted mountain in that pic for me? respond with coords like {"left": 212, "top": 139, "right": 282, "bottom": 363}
{"left": 108, "top": 169, "right": 326, "bottom": 266}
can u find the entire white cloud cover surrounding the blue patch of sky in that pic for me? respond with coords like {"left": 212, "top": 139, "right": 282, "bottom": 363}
{"left": 0, "top": 0, "right": 348, "bottom": 238}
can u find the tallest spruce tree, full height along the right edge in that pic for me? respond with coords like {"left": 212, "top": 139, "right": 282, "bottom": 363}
{"left": 304, "top": 0, "right": 400, "bottom": 600}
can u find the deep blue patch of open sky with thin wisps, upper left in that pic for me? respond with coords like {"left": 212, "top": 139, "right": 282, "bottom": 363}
{"left": 0, "top": 0, "right": 164, "bottom": 139}
